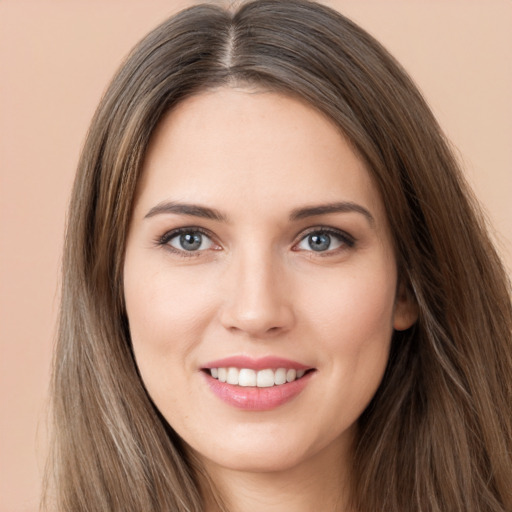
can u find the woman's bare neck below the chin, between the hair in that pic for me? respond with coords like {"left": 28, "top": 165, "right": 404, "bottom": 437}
{"left": 195, "top": 438, "right": 350, "bottom": 512}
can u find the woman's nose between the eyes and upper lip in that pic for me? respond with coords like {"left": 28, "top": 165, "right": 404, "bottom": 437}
{"left": 220, "top": 249, "right": 295, "bottom": 339}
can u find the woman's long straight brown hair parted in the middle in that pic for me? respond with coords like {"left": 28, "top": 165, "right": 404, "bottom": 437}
{"left": 42, "top": 0, "right": 512, "bottom": 512}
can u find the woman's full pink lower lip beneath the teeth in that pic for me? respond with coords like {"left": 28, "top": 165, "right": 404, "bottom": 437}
{"left": 203, "top": 372, "right": 315, "bottom": 411}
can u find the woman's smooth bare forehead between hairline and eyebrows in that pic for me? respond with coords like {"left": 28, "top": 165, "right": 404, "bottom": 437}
{"left": 137, "top": 88, "right": 380, "bottom": 222}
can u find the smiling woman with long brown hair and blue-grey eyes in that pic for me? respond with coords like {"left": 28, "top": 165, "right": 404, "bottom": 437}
{"left": 44, "top": 0, "right": 512, "bottom": 512}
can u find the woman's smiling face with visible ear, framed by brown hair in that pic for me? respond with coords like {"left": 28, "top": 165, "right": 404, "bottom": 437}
{"left": 124, "top": 88, "right": 414, "bottom": 471}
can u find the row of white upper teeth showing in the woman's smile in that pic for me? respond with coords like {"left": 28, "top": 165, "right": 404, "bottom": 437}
{"left": 210, "top": 367, "right": 306, "bottom": 388}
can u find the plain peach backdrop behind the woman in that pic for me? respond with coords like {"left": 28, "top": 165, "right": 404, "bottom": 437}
{"left": 0, "top": 0, "right": 512, "bottom": 512}
